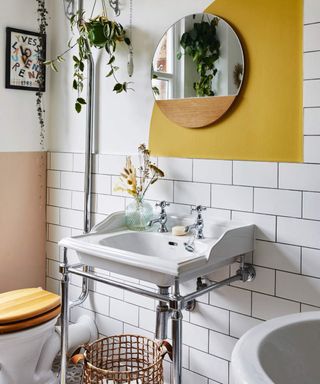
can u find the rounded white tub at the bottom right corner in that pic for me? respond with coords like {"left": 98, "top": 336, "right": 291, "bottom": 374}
{"left": 231, "top": 311, "right": 320, "bottom": 384}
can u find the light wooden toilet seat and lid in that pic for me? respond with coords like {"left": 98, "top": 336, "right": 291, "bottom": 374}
{"left": 0, "top": 288, "right": 61, "bottom": 334}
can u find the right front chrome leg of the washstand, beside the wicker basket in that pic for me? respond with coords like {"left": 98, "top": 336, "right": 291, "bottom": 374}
{"left": 171, "top": 280, "right": 183, "bottom": 384}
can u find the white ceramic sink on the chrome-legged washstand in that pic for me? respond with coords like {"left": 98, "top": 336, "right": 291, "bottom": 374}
{"left": 59, "top": 212, "right": 254, "bottom": 287}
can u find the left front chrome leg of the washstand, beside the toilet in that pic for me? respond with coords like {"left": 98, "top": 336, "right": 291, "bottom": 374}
{"left": 60, "top": 248, "right": 69, "bottom": 384}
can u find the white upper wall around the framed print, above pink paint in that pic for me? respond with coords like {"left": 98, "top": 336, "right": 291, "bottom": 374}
{"left": 0, "top": 0, "right": 49, "bottom": 152}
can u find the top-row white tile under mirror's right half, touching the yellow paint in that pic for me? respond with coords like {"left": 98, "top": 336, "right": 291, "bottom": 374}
{"left": 193, "top": 159, "right": 232, "bottom": 184}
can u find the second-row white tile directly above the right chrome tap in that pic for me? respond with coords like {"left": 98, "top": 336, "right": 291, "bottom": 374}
{"left": 174, "top": 181, "right": 210, "bottom": 207}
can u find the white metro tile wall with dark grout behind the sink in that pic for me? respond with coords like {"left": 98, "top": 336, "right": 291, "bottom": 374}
{"left": 46, "top": 4, "right": 320, "bottom": 384}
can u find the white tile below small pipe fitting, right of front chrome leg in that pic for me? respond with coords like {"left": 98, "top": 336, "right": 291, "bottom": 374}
{"left": 190, "top": 302, "right": 229, "bottom": 333}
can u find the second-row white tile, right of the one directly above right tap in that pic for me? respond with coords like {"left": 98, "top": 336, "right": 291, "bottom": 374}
{"left": 211, "top": 185, "right": 253, "bottom": 211}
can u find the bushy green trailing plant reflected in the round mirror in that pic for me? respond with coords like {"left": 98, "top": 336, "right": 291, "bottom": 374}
{"left": 177, "top": 16, "right": 220, "bottom": 97}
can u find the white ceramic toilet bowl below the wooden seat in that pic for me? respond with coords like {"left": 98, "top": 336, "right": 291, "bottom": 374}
{"left": 0, "top": 318, "right": 58, "bottom": 384}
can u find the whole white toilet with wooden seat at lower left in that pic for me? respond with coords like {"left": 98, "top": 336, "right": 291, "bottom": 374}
{"left": 0, "top": 288, "right": 61, "bottom": 384}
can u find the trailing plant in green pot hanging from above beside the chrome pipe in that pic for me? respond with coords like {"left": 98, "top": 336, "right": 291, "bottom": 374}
{"left": 45, "top": 0, "right": 132, "bottom": 113}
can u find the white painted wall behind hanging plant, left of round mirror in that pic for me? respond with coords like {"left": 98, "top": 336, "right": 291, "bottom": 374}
{"left": 49, "top": 0, "right": 212, "bottom": 153}
